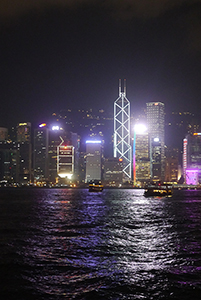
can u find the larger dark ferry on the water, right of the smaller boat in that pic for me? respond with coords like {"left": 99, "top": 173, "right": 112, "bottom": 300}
{"left": 144, "top": 185, "right": 173, "bottom": 197}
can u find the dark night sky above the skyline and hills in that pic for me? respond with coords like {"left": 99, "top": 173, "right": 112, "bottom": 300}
{"left": 0, "top": 0, "right": 201, "bottom": 126}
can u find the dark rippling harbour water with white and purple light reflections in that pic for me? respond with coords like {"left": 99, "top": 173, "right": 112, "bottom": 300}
{"left": 0, "top": 189, "right": 201, "bottom": 300}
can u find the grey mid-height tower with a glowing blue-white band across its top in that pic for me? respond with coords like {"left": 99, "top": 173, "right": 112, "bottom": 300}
{"left": 85, "top": 140, "right": 102, "bottom": 182}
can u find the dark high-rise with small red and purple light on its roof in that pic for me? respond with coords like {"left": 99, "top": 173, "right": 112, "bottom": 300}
{"left": 33, "top": 124, "right": 49, "bottom": 183}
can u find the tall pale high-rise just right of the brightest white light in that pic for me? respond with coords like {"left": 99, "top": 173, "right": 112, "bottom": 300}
{"left": 146, "top": 102, "right": 165, "bottom": 181}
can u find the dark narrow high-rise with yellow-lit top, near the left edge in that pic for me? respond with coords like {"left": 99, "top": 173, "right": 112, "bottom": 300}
{"left": 17, "top": 122, "right": 32, "bottom": 184}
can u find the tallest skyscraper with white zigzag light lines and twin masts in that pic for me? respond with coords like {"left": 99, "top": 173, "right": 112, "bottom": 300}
{"left": 114, "top": 80, "right": 131, "bottom": 180}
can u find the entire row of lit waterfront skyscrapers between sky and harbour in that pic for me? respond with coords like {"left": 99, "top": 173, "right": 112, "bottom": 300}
{"left": 0, "top": 81, "right": 201, "bottom": 187}
